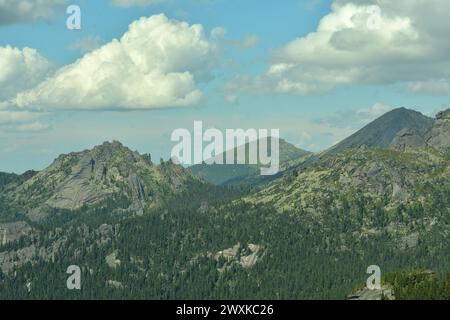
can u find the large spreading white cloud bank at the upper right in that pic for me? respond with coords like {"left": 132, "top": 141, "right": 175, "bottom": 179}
{"left": 230, "top": 0, "right": 450, "bottom": 95}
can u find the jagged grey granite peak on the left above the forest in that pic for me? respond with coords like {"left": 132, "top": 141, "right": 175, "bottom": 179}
{"left": 3, "top": 141, "right": 200, "bottom": 219}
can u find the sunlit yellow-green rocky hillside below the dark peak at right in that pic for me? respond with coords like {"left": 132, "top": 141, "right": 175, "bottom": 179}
{"left": 249, "top": 147, "right": 450, "bottom": 214}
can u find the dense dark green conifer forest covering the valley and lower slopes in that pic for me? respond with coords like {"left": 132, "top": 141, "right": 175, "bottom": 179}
{"left": 0, "top": 180, "right": 450, "bottom": 299}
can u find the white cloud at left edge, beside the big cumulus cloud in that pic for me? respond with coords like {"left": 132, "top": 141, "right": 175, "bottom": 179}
{"left": 0, "top": 46, "right": 51, "bottom": 100}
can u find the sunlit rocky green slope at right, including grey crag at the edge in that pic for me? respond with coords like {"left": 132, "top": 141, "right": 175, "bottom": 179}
{"left": 244, "top": 111, "right": 450, "bottom": 226}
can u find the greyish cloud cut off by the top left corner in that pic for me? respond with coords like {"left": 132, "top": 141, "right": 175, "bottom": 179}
{"left": 0, "top": 0, "right": 65, "bottom": 26}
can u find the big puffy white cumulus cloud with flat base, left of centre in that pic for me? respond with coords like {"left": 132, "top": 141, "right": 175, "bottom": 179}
{"left": 8, "top": 14, "right": 216, "bottom": 110}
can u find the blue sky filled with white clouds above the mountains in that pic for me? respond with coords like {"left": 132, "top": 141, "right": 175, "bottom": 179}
{"left": 0, "top": 0, "right": 450, "bottom": 173}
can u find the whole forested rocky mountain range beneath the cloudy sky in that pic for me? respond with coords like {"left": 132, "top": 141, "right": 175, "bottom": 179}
{"left": 0, "top": 108, "right": 450, "bottom": 299}
